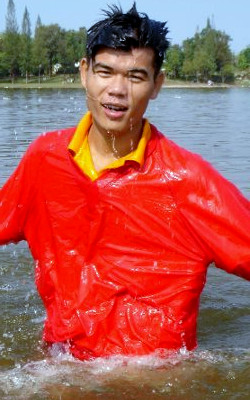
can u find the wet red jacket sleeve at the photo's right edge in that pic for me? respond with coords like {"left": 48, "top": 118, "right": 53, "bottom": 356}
{"left": 180, "top": 155, "right": 250, "bottom": 280}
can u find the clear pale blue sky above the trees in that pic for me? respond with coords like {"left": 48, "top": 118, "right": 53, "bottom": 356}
{"left": 0, "top": 0, "right": 250, "bottom": 53}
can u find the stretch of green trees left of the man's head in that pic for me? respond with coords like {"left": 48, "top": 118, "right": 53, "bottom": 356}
{"left": 0, "top": 0, "right": 87, "bottom": 79}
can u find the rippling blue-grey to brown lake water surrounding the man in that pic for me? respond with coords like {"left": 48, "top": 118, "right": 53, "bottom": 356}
{"left": 0, "top": 88, "right": 250, "bottom": 400}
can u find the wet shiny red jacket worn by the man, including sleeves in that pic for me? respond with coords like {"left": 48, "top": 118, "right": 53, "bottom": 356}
{"left": 0, "top": 126, "right": 250, "bottom": 359}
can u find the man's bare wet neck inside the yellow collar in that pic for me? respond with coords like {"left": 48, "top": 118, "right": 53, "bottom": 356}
{"left": 88, "top": 124, "right": 142, "bottom": 171}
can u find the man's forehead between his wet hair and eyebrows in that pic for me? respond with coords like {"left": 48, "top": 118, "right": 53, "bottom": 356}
{"left": 93, "top": 47, "right": 154, "bottom": 70}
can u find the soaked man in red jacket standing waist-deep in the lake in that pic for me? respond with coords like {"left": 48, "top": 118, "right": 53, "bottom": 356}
{"left": 0, "top": 5, "right": 250, "bottom": 359}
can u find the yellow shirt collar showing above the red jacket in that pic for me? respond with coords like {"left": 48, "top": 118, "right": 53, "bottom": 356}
{"left": 68, "top": 112, "right": 151, "bottom": 181}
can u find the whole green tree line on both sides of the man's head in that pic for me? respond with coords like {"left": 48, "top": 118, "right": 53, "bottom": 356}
{"left": 0, "top": 0, "right": 250, "bottom": 82}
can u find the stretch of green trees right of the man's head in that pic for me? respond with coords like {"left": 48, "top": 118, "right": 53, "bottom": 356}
{"left": 164, "top": 18, "right": 250, "bottom": 83}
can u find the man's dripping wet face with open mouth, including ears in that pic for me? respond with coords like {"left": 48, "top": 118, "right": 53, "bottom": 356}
{"left": 81, "top": 48, "right": 163, "bottom": 139}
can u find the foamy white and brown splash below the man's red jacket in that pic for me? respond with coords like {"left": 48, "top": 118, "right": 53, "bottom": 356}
{"left": 0, "top": 345, "right": 250, "bottom": 400}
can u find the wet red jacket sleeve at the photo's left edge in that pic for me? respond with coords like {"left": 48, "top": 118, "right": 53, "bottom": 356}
{"left": 0, "top": 144, "right": 35, "bottom": 244}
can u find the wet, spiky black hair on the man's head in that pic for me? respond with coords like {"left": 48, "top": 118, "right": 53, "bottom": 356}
{"left": 86, "top": 2, "right": 169, "bottom": 75}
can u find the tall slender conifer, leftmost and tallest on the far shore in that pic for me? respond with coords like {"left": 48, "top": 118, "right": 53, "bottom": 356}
{"left": 3, "top": 0, "right": 20, "bottom": 80}
